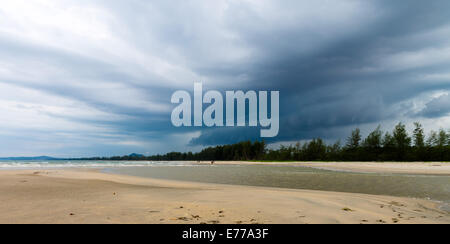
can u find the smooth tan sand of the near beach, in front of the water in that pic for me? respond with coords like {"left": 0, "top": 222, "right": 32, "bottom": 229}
{"left": 0, "top": 166, "right": 450, "bottom": 224}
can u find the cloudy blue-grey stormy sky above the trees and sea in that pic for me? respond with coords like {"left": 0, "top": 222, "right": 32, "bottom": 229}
{"left": 0, "top": 0, "right": 450, "bottom": 157}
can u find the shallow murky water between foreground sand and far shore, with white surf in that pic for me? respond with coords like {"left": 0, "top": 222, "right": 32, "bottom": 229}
{"left": 0, "top": 160, "right": 450, "bottom": 212}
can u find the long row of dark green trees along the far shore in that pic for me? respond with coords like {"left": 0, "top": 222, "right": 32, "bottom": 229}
{"left": 81, "top": 122, "right": 450, "bottom": 161}
